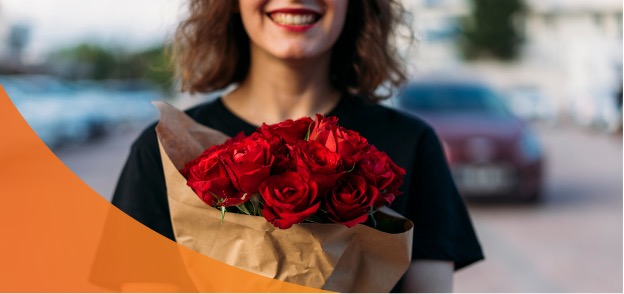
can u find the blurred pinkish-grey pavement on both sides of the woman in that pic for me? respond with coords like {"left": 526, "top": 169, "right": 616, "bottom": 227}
{"left": 57, "top": 121, "right": 623, "bottom": 292}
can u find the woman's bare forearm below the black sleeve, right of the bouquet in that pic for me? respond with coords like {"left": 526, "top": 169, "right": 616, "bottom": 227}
{"left": 402, "top": 260, "right": 454, "bottom": 293}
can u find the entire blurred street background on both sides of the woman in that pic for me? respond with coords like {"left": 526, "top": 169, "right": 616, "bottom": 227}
{"left": 0, "top": 0, "right": 623, "bottom": 293}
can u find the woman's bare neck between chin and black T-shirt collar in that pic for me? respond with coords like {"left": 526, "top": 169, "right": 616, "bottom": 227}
{"left": 223, "top": 45, "right": 340, "bottom": 125}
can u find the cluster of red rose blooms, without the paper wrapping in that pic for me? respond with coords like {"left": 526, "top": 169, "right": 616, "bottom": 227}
{"left": 181, "top": 115, "right": 405, "bottom": 229}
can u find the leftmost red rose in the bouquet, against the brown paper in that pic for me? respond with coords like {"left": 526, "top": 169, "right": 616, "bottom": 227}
{"left": 181, "top": 146, "right": 248, "bottom": 206}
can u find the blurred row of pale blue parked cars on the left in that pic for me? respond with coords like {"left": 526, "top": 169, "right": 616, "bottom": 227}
{"left": 0, "top": 75, "right": 163, "bottom": 149}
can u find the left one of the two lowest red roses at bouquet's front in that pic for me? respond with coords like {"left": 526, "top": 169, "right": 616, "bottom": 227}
{"left": 260, "top": 171, "right": 320, "bottom": 229}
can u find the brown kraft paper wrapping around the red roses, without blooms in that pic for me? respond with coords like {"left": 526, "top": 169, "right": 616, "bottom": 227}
{"left": 154, "top": 102, "right": 413, "bottom": 292}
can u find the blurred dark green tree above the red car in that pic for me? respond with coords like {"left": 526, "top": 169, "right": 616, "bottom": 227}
{"left": 460, "top": 0, "right": 525, "bottom": 60}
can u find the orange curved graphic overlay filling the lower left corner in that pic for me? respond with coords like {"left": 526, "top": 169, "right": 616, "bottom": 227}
{"left": 0, "top": 87, "right": 320, "bottom": 292}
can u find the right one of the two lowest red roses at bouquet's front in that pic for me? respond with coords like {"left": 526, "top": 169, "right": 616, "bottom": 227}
{"left": 325, "top": 173, "right": 379, "bottom": 228}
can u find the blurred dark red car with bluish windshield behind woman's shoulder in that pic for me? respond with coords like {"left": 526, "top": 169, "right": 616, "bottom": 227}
{"left": 398, "top": 80, "right": 543, "bottom": 201}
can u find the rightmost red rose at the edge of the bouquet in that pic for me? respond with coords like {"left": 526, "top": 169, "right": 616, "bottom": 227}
{"left": 358, "top": 146, "right": 405, "bottom": 208}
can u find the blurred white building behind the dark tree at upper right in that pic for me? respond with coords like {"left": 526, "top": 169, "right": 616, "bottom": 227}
{"left": 403, "top": 0, "right": 622, "bottom": 128}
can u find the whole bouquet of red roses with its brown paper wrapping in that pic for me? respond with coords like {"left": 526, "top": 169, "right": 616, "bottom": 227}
{"left": 156, "top": 103, "right": 413, "bottom": 292}
